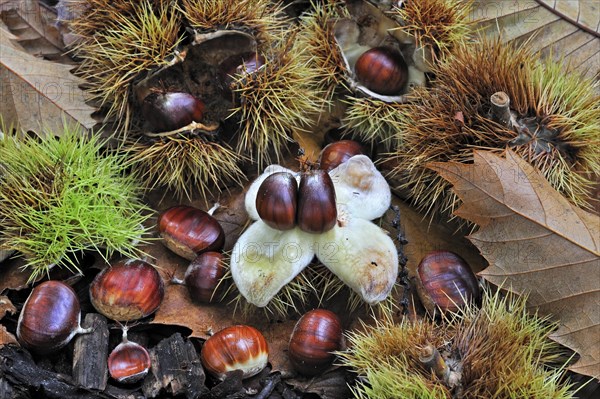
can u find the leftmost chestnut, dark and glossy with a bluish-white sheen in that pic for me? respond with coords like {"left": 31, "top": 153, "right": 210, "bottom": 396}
{"left": 17, "top": 281, "right": 91, "bottom": 354}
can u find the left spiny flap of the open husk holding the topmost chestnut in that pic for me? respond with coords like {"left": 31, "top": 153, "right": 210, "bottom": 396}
{"left": 296, "top": 1, "right": 349, "bottom": 100}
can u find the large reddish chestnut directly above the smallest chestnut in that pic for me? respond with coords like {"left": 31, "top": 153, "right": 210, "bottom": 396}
{"left": 90, "top": 259, "right": 165, "bottom": 321}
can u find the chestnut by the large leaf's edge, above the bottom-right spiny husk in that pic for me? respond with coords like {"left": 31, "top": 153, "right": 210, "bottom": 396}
{"left": 416, "top": 251, "right": 480, "bottom": 314}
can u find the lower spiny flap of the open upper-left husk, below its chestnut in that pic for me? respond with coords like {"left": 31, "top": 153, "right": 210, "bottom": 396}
{"left": 125, "top": 134, "right": 245, "bottom": 199}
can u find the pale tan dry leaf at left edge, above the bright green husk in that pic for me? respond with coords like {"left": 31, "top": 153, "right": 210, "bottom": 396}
{"left": 0, "top": 27, "right": 96, "bottom": 134}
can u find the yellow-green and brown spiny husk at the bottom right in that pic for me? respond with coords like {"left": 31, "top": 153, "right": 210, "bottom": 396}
{"left": 339, "top": 289, "right": 573, "bottom": 399}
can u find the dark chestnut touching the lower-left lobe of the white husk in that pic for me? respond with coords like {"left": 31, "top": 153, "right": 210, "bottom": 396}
{"left": 184, "top": 251, "right": 226, "bottom": 303}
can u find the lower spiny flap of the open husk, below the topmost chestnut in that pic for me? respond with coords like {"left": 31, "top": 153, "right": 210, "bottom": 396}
{"left": 341, "top": 97, "right": 405, "bottom": 150}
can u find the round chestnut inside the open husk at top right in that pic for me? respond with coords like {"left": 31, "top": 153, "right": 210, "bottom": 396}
{"left": 354, "top": 46, "right": 408, "bottom": 96}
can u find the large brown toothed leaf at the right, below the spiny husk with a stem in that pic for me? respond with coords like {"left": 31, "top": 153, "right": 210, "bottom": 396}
{"left": 429, "top": 150, "right": 600, "bottom": 378}
